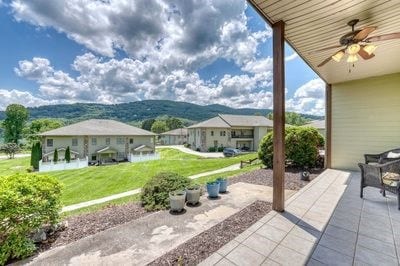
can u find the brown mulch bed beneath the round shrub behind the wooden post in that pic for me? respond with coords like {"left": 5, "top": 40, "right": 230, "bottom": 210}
{"left": 229, "top": 168, "right": 324, "bottom": 190}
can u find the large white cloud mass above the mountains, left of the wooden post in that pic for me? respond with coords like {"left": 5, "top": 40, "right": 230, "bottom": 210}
{"left": 11, "top": 0, "right": 272, "bottom": 108}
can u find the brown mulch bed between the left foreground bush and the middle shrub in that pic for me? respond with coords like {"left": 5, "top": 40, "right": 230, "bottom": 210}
{"left": 38, "top": 203, "right": 151, "bottom": 252}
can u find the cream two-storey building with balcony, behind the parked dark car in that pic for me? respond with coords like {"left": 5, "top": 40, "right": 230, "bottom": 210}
{"left": 188, "top": 114, "right": 272, "bottom": 151}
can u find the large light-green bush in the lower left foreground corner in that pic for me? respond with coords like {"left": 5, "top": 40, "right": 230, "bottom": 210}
{"left": 0, "top": 174, "right": 61, "bottom": 265}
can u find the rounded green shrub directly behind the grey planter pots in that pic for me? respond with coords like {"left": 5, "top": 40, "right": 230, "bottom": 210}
{"left": 140, "top": 172, "right": 191, "bottom": 211}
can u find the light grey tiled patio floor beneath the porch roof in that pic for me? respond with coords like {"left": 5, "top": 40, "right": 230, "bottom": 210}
{"left": 201, "top": 169, "right": 400, "bottom": 266}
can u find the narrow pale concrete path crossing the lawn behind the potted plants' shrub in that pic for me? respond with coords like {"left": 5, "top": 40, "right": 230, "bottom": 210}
{"left": 61, "top": 164, "right": 240, "bottom": 213}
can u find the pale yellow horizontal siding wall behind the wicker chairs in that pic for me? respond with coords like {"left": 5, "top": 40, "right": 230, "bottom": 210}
{"left": 332, "top": 70, "right": 400, "bottom": 170}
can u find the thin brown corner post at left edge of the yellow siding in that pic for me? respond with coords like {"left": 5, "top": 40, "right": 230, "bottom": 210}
{"left": 325, "top": 84, "right": 332, "bottom": 168}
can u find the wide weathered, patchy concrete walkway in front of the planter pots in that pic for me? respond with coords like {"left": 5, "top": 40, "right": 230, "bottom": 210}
{"left": 20, "top": 183, "right": 295, "bottom": 265}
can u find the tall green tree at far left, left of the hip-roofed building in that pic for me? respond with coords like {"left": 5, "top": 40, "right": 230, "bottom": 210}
{"left": 3, "top": 104, "right": 29, "bottom": 144}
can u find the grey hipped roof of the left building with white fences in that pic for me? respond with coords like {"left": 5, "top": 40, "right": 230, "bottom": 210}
{"left": 39, "top": 119, "right": 156, "bottom": 136}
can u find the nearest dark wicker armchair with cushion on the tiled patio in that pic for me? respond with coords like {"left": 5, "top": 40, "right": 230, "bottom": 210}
{"left": 358, "top": 159, "right": 400, "bottom": 210}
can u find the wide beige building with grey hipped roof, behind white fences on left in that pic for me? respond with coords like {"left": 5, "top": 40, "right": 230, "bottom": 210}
{"left": 40, "top": 119, "right": 156, "bottom": 162}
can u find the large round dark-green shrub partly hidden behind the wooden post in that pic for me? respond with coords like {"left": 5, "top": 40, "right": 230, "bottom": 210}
{"left": 258, "top": 126, "right": 324, "bottom": 168}
